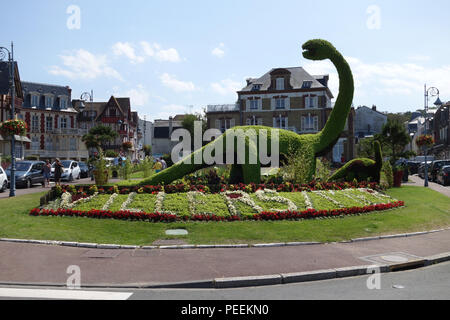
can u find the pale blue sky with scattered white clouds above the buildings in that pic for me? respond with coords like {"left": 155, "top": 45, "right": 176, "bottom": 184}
{"left": 0, "top": 0, "right": 450, "bottom": 120}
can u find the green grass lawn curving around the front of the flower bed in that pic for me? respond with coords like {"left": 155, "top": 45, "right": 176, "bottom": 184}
{"left": 0, "top": 186, "right": 450, "bottom": 245}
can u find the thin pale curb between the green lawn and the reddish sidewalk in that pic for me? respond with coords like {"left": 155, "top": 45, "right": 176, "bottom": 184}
{"left": 0, "top": 228, "right": 450, "bottom": 250}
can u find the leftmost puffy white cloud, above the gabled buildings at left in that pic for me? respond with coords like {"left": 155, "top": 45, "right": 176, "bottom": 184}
{"left": 49, "top": 49, "right": 123, "bottom": 80}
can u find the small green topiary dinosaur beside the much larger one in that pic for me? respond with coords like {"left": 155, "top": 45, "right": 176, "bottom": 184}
{"left": 328, "top": 141, "right": 383, "bottom": 183}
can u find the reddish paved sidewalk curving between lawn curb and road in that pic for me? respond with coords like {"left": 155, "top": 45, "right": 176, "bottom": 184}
{"left": 0, "top": 230, "right": 450, "bottom": 286}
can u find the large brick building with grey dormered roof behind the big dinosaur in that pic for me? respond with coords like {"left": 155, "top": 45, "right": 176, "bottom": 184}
{"left": 206, "top": 67, "right": 355, "bottom": 162}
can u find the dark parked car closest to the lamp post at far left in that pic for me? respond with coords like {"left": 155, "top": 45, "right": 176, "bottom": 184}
{"left": 6, "top": 161, "right": 45, "bottom": 188}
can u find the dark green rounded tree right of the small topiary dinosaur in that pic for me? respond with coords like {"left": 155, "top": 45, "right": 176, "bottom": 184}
{"left": 375, "top": 119, "right": 411, "bottom": 164}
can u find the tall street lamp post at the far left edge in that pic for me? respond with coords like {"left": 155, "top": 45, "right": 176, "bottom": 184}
{"left": 0, "top": 42, "right": 16, "bottom": 197}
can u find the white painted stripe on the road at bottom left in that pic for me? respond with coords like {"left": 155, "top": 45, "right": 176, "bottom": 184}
{"left": 0, "top": 288, "right": 133, "bottom": 300}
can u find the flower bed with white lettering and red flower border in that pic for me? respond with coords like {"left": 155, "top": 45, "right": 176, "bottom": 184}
{"left": 30, "top": 185, "right": 404, "bottom": 222}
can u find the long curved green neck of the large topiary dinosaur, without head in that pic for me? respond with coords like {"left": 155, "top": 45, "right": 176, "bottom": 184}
{"left": 316, "top": 50, "right": 355, "bottom": 154}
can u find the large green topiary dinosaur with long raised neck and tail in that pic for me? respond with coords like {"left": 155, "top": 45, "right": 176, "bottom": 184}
{"left": 141, "top": 39, "right": 354, "bottom": 185}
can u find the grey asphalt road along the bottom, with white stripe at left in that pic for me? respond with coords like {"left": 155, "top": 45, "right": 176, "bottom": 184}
{"left": 0, "top": 262, "right": 450, "bottom": 305}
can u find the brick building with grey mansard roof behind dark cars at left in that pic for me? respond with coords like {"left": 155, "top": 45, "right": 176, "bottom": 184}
{"left": 21, "top": 81, "right": 88, "bottom": 161}
